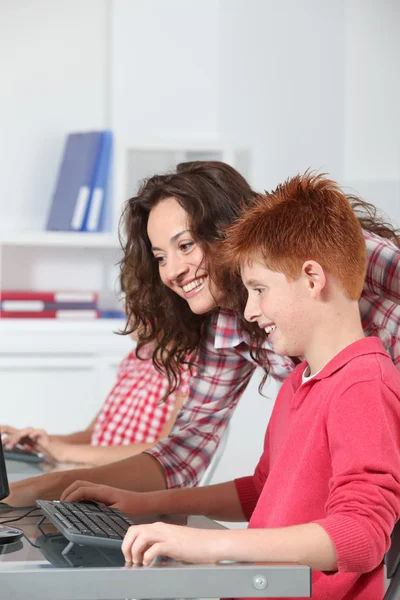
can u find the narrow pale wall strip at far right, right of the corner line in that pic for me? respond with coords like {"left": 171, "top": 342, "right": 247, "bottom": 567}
{"left": 343, "top": 0, "right": 400, "bottom": 226}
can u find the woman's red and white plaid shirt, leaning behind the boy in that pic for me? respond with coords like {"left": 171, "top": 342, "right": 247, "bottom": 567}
{"left": 148, "top": 232, "right": 400, "bottom": 488}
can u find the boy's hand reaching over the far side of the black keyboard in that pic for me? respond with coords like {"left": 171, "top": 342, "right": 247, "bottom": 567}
{"left": 61, "top": 481, "right": 147, "bottom": 515}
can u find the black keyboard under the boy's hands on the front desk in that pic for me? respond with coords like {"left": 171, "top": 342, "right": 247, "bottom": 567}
{"left": 36, "top": 500, "right": 134, "bottom": 548}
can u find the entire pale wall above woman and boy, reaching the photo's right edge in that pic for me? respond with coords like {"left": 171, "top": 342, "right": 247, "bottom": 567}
{"left": 220, "top": 0, "right": 400, "bottom": 224}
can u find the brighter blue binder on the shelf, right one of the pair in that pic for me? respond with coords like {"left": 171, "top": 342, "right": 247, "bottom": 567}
{"left": 81, "top": 130, "right": 113, "bottom": 232}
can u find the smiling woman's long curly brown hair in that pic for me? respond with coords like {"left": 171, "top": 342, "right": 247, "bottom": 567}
{"left": 120, "top": 161, "right": 256, "bottom": 393}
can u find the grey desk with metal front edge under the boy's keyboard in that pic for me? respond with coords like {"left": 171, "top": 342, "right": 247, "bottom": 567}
{"left": 0, "top": 461, "right": 311, "bottom": 600}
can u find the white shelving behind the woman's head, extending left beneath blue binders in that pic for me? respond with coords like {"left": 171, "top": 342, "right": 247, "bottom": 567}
{"left": 0, "top": 136, "right": 249, "bottom": 298}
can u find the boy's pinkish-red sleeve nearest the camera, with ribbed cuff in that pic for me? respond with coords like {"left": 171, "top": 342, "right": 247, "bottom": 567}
{"left": 316, "top": 379, "right": 400, "bottom": 572}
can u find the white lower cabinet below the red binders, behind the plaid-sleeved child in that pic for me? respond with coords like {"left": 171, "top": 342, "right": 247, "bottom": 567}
{"left": 0, "top": 319, "right": 134, "bottom": 433}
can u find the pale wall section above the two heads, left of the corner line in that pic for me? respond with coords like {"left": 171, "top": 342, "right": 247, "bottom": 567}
{"left": 220, "top": 0, "right": 345, "bottom": 189}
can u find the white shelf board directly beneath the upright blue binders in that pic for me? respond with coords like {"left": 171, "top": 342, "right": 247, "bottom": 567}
{"left": 0, "top": 231, "right": 120, "bottom": 250}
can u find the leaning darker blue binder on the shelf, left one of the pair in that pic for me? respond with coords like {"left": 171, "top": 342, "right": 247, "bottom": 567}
{"left": 47, "top": 131, "right": 102, "bottom": 231}
